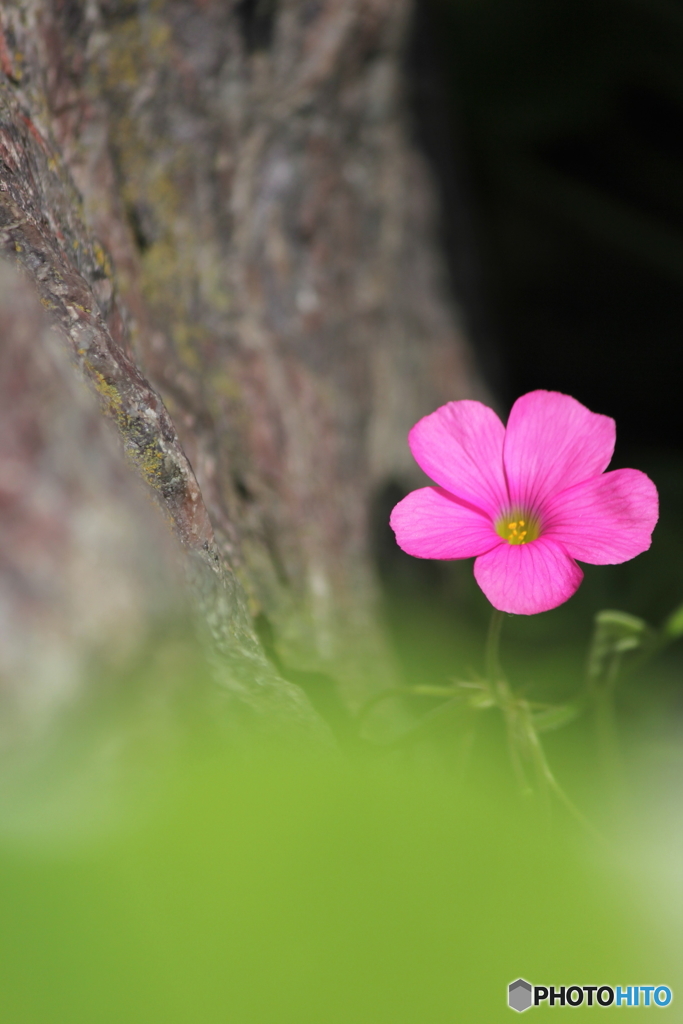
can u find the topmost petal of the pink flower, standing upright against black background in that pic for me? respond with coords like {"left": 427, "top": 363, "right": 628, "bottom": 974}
{"left": 504, "top": 391, "right": 616, "bottom": 513}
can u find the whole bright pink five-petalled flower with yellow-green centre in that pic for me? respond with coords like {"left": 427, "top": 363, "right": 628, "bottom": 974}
{"left": 390, "top": 391, "right": 658, "bottom": 615}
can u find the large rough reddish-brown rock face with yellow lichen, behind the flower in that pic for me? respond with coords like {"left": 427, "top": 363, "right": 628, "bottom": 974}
{"left": 0, "top": 0, "right": 481, "bottom": 720}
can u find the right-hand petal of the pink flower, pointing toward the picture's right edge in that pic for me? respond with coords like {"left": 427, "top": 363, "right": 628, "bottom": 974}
{"left": 543, "top": 469, "right": 659, "bottom": 565}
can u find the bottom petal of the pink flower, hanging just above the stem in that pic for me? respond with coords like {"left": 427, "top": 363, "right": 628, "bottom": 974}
{"left": 474, "top": 537, "right": 584, "bottom": 615}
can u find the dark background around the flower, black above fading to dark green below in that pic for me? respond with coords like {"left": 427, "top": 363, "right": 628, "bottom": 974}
{"left": 377, "top": 0, "right": 683, "bottom": 745}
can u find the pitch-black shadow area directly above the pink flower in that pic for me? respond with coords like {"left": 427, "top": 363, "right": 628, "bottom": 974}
{"left": 410, "top": 0, "right": 683, "bottom": 451}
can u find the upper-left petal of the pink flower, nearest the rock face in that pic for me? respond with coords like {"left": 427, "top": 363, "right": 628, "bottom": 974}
{"left": 408, "top": 399, "right": 509, "bottom": 519}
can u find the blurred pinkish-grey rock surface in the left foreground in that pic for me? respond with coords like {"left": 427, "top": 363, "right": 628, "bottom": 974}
{"left": 0, "top": 265, "right": 182, "bottom": 738}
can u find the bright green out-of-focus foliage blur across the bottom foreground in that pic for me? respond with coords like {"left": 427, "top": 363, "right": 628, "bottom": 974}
{"left": 0, "top": 737, "right": 683, "bottom": 1024}
